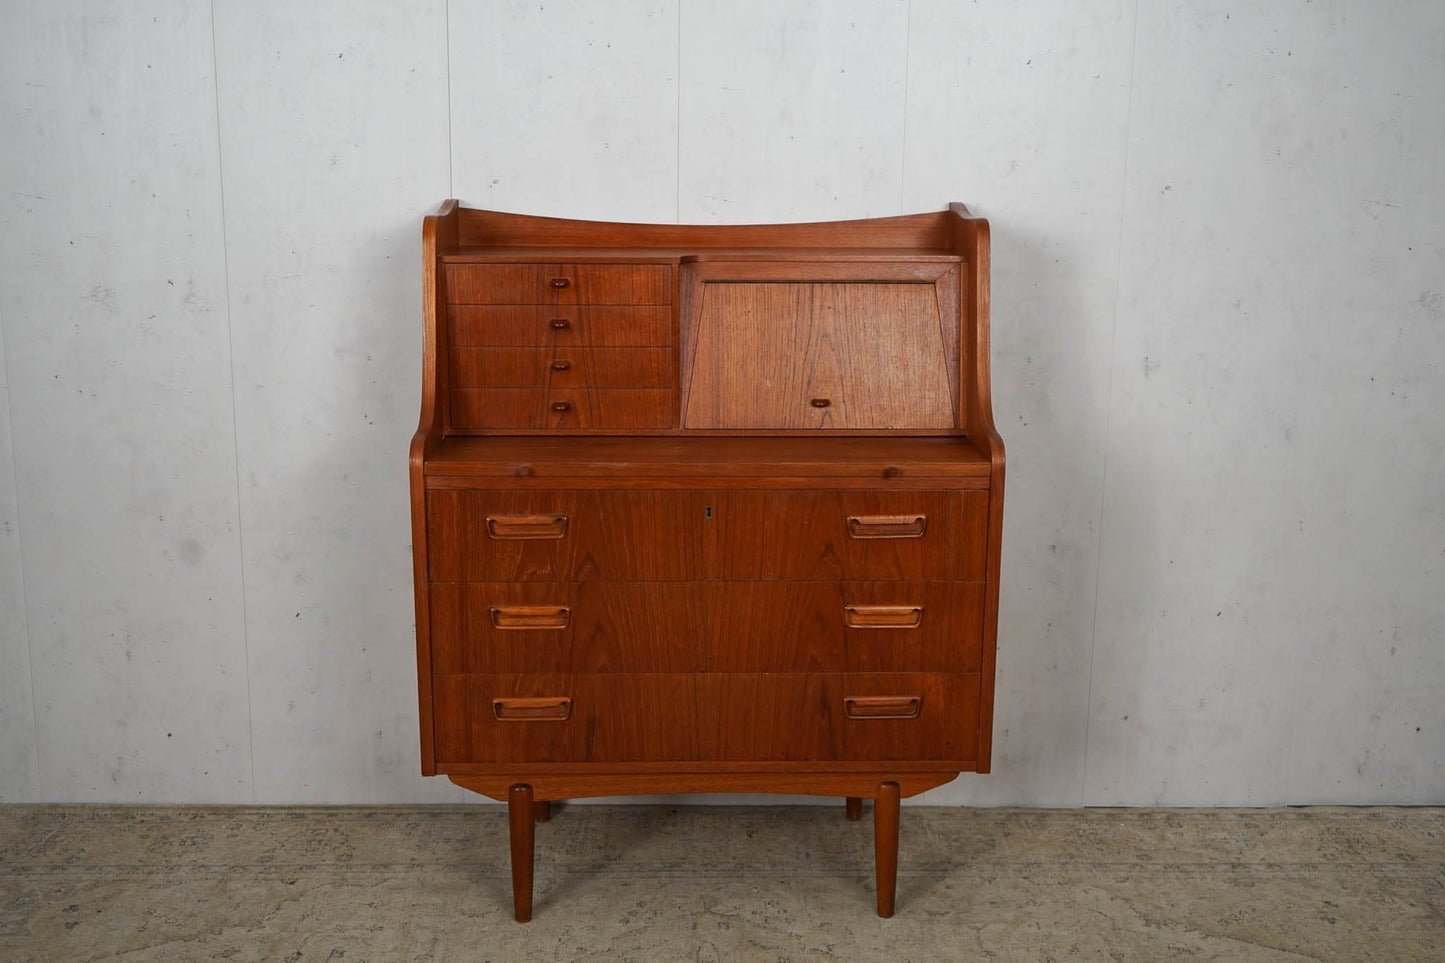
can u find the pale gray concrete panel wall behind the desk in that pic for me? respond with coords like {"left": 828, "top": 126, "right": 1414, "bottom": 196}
{"left": 0, "top": 0, "right": 1445, "bottom": 805}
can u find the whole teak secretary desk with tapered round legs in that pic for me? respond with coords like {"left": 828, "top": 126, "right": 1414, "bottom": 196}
{"left": 410, "top": 201, "right": 1004, "bottom": 921}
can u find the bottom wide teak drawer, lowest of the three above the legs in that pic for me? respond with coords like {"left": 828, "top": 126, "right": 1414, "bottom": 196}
{"left": 421, "top": 672, "right": 978, "bottom": 765}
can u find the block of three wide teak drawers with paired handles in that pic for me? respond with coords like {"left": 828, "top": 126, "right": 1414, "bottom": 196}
{"left": 426, "top": 489, "right": 988, "bottom": 762}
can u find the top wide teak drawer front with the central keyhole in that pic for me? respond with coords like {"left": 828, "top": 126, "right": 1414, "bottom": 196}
{"left": 428, "top": 489, "right": 988, "bottom": 578}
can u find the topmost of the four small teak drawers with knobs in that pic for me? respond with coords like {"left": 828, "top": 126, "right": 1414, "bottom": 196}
{"left": 445, "top": 263, "right": 672, "bottom": 304}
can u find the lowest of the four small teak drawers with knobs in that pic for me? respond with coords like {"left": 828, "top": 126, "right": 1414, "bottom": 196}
{"left": 451, "top": 388, "right": 678, "bottom": 428}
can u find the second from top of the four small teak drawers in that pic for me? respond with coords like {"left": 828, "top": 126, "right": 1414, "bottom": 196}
{"left": 447, "top": 305, "right": 673, "bottom": 350}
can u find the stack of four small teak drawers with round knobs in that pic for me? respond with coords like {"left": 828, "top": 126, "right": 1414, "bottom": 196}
{"left": 444, "top": 263, "right": 678, "bottom": 431}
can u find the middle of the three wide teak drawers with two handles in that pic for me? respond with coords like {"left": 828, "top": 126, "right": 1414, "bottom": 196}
{"left": 431, "top": 581, "right": 984, "bottom": 674}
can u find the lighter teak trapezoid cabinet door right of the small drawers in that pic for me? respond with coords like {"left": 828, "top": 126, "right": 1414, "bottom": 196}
{"left": 683, "top": 282, "right": 958, "bottom": 429}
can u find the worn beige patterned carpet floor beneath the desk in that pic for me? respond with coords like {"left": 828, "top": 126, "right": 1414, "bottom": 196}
{"left": 0, "top": 803, "right": 1445, "bottom": 963}
